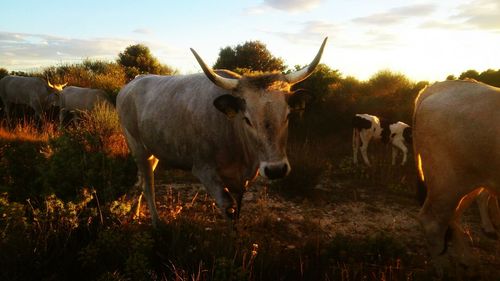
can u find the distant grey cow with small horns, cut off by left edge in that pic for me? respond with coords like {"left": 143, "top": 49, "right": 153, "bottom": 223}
{"left": 0, "top": 76, "right": 67, "bottom": 123}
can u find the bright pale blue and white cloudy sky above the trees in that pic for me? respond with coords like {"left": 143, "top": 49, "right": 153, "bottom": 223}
{"left": 0, "top": 0, "right": 500, "bottom": 81}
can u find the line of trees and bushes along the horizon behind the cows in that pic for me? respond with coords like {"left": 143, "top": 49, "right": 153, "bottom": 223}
{"left": 0, "top": 41, "right": 500, "bottom": 135}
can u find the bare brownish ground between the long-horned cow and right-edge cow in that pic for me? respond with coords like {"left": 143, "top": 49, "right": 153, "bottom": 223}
{"left": 152, "top": 174, "right": 500, "bottom": 280}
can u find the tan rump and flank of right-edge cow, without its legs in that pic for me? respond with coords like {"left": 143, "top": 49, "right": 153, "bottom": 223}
{"left": 413, "top": 81, "right": 500, "bottom": 184}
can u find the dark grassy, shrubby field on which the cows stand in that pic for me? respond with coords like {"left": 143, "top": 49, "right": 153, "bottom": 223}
{"left": 0, "top": 110, "right": 500, "bottom": 280}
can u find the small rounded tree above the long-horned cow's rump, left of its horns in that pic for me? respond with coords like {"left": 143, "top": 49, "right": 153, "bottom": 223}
{"left": 117, "top": 44, "right": 174, "bottom": 80}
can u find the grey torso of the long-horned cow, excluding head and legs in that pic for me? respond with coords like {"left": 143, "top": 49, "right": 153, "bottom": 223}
{"left": 116, "top": 74, "right": 232, "bottom": 167}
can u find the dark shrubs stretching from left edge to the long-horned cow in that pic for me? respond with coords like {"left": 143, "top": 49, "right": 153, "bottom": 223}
{"left": 0, "top": 105, "right": 136, "bottom": 202}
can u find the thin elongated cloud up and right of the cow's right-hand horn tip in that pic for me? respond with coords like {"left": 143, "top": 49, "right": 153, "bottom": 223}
{"left": 353, "top": 4, "right": 436, "bottom": 25}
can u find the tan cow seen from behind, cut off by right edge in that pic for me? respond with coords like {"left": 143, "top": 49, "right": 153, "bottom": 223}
{"left": 413, "top": 78, "right": 500, "bottom": 275}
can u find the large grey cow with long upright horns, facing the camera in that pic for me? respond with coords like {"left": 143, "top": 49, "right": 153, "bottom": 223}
{"left": 116, "top": 38, "right": 326, "bottom": 225}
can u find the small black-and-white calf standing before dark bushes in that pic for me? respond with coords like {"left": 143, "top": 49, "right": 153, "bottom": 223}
{"left": 352, "top": 114, "right": 411, "bottom": 166}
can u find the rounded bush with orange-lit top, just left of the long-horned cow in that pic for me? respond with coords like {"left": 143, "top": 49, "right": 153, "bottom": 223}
{"left": 43, "top": 105, "right": 136, "bottom": 202}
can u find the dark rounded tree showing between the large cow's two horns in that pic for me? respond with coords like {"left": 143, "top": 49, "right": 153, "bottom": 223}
{"left": 214, "top": 41, "right": 286, "bottom": 73}
